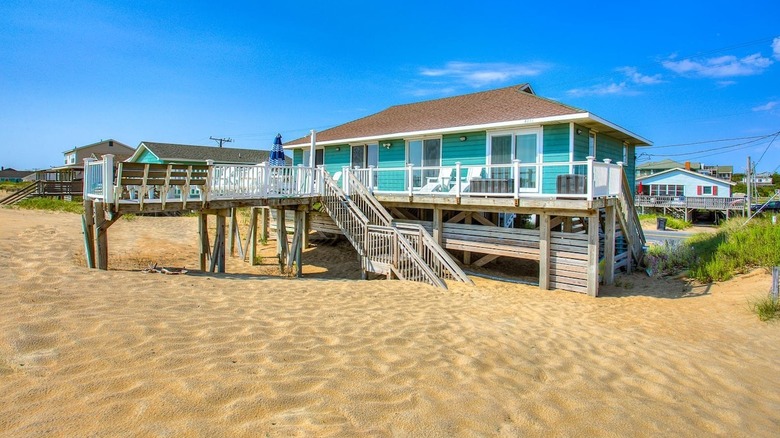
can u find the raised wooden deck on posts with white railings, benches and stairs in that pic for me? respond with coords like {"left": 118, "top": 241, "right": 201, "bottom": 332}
{"left": 77, "top": 156, "right": 644, "bottom": 296}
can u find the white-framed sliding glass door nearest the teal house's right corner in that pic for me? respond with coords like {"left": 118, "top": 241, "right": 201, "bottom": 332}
{"left": 487, "top": 128, "right": 542, "bottom": 191}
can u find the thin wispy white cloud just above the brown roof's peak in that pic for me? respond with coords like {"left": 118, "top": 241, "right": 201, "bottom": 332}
{"left": 420, "top": 61, "right": 549, "bottom": 88}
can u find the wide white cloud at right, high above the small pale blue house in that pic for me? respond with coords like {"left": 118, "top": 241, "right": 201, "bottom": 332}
{"left": 661, "top": 51, "right": 780, "bottom": 78}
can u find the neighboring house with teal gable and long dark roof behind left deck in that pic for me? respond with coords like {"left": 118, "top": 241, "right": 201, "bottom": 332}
{"left": 127, "top": 141, "right": 290, "bottom": 164}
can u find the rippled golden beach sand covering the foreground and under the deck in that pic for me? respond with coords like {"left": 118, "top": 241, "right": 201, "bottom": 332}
{"left": 0, "top": 209, "right": 780, "bottom": 437}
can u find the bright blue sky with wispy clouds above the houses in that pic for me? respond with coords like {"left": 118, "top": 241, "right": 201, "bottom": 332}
{"left": 0, "top": 0, "right": 780, "bottom": 172}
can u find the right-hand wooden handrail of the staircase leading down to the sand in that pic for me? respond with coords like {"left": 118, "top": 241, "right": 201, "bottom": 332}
{"left": 346, "top": 171, "right": 474, "bottom": 284}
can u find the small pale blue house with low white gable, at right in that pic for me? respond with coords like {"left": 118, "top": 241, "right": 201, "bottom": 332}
{"left": 637, "top": 169, "right": 736, "bottom": 198}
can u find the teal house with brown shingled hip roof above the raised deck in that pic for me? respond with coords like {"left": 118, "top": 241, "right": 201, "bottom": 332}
{"left": 285, "top": 84, "right": 650, "bottom": 193}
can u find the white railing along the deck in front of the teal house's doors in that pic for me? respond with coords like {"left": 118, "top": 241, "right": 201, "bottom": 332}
{"left": 350, "top": 157, "right": 623, "bottom": 200}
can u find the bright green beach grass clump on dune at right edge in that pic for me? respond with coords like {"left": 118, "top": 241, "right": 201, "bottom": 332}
{"left": 689, "top": 219, "right": 780, "bottom": 283}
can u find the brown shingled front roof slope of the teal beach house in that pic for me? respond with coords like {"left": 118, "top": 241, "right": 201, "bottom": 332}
{"left": 285, "top": 84, "right": 585, "bottom": 146}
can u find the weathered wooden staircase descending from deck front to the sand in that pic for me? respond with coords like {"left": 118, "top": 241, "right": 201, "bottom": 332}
{"left": 323, "top": 172, "right": 473, "bottom": 288}
